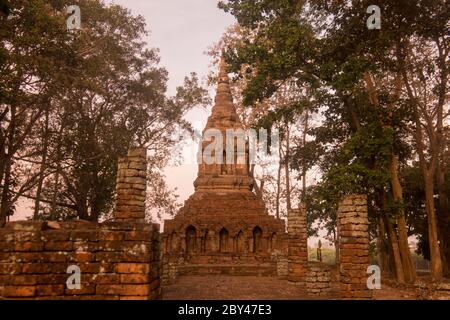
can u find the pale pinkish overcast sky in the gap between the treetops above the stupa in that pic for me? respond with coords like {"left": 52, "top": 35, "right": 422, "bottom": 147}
{"left": 107, "top": 0, "right": 235, "bottom": 93}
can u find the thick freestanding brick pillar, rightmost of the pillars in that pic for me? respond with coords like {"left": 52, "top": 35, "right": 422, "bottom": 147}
{"left": 338, "top": 195, "right": 372, "bottom": 299}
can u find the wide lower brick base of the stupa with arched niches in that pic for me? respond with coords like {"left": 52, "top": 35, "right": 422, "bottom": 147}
{"left": 162, "top": 191, "right": 287, "bottom": 275}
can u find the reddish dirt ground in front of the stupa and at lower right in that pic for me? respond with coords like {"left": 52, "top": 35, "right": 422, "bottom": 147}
{"left": 163, "top": 275, "right": 450, "bottom": 300}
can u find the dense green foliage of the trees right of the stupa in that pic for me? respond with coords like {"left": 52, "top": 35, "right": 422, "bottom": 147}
{"left": 219, "top": 0, "right": 448, "bottom": 254}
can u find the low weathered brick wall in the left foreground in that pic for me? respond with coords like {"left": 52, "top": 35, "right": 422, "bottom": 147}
{"left": 0, "top": 221, "right": 160, "bottom": 299}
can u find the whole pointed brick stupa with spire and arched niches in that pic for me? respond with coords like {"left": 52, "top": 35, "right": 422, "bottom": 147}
{"left": 163, "top": 59, "right": 285, "bottom": 272}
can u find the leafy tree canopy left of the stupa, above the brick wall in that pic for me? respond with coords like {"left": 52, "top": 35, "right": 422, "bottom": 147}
{"left": 0, "top": 0, "right": 209, "bottom": 221}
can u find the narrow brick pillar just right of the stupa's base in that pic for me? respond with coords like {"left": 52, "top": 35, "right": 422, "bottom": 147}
{"left": 288, "top": 204, "right": 308, "bottom": 284}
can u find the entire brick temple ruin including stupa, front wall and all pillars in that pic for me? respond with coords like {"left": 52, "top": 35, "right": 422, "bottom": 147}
{"left": 0, "top": 61, "right": 372, "bottom": 300}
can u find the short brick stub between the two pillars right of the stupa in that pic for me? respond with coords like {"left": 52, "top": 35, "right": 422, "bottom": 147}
{"left": 306, "top": 262, "right": 331, "bottom": 296}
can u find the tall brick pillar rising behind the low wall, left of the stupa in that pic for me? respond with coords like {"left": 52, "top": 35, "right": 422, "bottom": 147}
{"left": 114, "top": 148, "right": 147, "bottom": 222}
